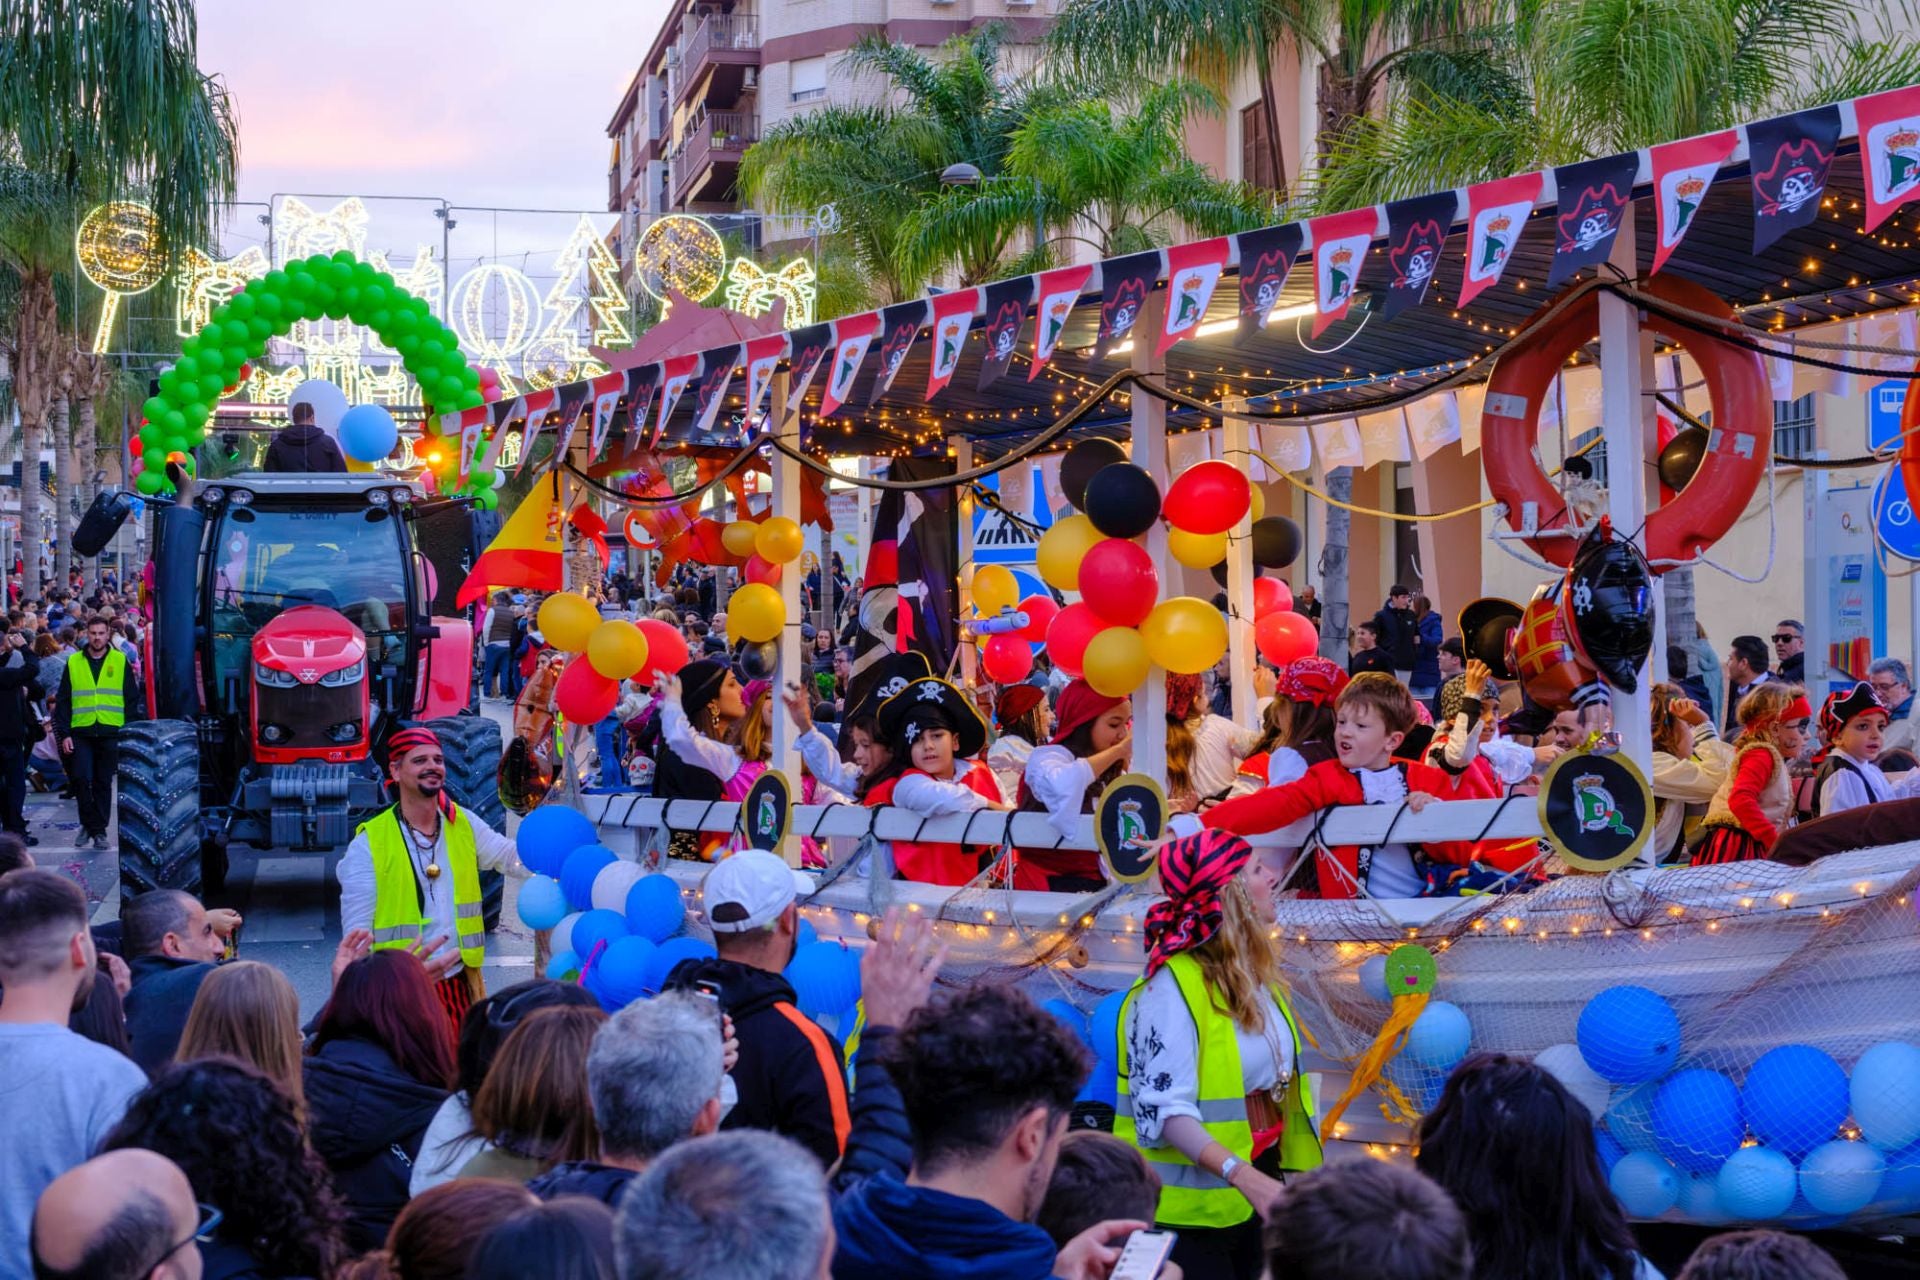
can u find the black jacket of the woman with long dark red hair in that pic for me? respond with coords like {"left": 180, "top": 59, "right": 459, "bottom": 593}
{"left": 305, "top": 1040, "right": 447, "bottom": 1251}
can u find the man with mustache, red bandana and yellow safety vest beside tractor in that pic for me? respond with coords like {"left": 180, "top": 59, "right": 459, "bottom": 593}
{"left": 340, "top": 727, "right": 526, "bottom": 1034}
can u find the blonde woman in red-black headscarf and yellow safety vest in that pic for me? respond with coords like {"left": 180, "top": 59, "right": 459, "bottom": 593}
{"left": 1114, "top": 831, "right": 1321, "bottom": 1278}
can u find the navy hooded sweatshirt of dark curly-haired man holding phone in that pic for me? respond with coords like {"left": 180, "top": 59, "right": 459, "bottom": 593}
{"left": 833, "top": 1173, "right": 1058, "bottom": 1280}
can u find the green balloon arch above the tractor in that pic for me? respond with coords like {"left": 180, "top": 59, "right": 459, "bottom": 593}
{"left": 134, "top": 249, "right": 499, "bottom": 507}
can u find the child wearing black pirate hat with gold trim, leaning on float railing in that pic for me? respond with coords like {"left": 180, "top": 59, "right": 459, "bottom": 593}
{"left": 866, "top": 677, "right": 1010, "bottom": 885}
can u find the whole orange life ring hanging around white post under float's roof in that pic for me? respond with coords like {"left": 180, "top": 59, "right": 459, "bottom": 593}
{"left": 1480, "top": 276, "right": 1766, "bottom": 574}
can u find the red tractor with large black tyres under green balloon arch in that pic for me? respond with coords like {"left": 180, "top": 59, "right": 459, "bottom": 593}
{"left": 119, "top": 468, "right": 505, "bottom": 929}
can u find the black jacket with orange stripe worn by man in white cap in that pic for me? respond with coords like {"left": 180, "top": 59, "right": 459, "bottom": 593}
{"left": 666, "top": 960, "right": 852, "bottom": 1165}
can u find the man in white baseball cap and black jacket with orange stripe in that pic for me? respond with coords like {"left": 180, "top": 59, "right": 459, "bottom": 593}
{"left": 664, "top": 848, "right": 851, "bottom": 1165}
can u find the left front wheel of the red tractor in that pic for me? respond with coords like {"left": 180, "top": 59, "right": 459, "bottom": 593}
{"left": 119, "top": 720, "right": 202, "bottom": 902}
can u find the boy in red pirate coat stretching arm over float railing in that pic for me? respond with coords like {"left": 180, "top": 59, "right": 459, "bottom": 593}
{"left": 1175, "top": 672, "right": 1500, "bottom": 898}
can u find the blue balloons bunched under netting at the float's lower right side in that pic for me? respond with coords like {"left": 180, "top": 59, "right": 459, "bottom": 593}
{"left": 1566, "top": 986, "right": 1920, "bottom": 1222}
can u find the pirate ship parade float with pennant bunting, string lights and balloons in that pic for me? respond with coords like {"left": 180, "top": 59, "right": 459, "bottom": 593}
{"left": 442, "top": 90, "right": 1920, "bottom": 1228}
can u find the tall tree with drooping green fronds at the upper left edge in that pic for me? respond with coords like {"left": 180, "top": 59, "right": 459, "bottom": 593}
{"left": 0, "top": 0, "right": 238, "bottom": 591}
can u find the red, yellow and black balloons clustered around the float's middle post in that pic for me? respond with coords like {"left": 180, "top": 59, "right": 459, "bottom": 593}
{"left": 1029, "top": 439, "right": 1317, "bottom": 697}
